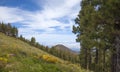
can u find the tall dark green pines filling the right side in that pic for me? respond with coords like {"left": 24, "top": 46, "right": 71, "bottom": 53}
{"left": 73, "top": 0, "right": 120, "bottom": 72}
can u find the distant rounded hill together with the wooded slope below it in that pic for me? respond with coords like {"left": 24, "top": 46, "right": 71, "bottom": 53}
{"left": 50, "top": 44, "right": 80, "bottom": 64}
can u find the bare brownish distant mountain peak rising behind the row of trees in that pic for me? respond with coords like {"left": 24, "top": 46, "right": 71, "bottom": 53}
{"left": 54, "top": 44, "right": 79, "bottom": 54}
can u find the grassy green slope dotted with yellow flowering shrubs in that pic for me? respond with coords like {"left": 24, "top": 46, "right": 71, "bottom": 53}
{"left": 0, "top": 33, "right": 86, "bottom": 72}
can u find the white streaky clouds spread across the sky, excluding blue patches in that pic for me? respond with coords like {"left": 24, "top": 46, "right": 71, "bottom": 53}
{"left": 0, "top": 0, "right": 80, "bottom": 48}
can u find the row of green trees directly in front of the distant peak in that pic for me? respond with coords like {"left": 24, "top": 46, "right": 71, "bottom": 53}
{"left": 49, "top": 46, "right": 79, "bottom": 63}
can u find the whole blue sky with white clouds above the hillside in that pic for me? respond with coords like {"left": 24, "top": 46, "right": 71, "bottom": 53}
{"left": 0, "top": 0, "right": 80, "bottom": 50}
